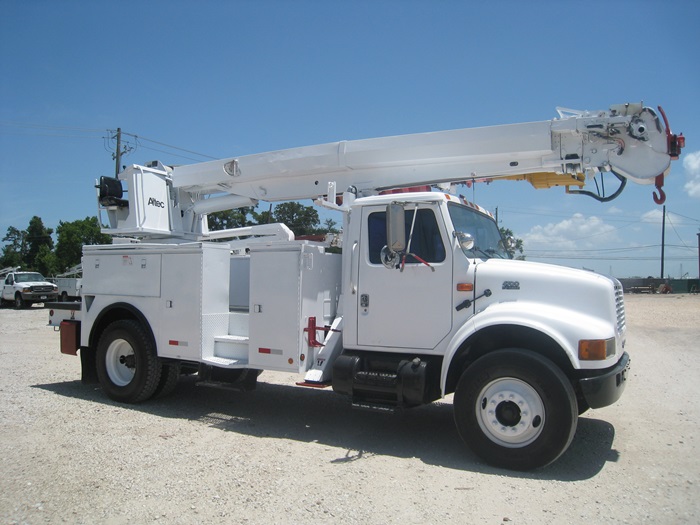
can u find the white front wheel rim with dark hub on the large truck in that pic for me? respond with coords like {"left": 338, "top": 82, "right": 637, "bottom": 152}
{"left": 476, "top": 377, "right": 545, "bottom": 448}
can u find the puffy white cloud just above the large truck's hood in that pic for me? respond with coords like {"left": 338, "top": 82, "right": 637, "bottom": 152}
{"left": 522, "top": 213, "right": 619, "bottom": 253}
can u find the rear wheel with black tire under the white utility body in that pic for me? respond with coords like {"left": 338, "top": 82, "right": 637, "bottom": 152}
{"left": 97, "top": 319, "right": 163, "bottom": 403}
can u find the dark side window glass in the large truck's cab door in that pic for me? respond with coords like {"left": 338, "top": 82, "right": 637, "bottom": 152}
{"left": 367, "top": 209, "right": 445, "bottom": 264}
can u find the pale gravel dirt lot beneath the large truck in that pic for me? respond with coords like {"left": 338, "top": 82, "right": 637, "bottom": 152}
{"left": 0, "top": 295, "right": 700, "bottom": 525}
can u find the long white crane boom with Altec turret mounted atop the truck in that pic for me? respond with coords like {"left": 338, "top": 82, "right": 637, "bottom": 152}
{"left": 101, "top": 103, "right": 685, "bottom": 239}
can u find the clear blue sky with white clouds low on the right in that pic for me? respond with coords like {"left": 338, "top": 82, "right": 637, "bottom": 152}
{"left": 0, "top": 0, "right": 700, "bottom": 278}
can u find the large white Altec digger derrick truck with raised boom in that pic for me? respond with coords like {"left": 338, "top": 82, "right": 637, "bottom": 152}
{"left": 50, "top": 104, "right": 684, "bottom": 469}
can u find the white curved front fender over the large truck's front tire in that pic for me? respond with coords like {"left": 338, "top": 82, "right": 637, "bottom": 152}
{"left": 440, "top": 301, "right": 620, "bottom": 395}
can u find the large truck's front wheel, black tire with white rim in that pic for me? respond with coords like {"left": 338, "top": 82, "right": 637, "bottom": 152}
{"left": 454, "top": 348, "right": 578, "bottom": 470}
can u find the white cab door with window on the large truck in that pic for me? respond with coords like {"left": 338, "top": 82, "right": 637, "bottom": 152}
{"left": 356, "top": 203, "right": 453, "bottom": 351}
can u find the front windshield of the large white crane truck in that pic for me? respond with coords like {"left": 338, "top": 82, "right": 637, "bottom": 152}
{"left": 448, "top": 202, "right": 510, "bottom": 259}
